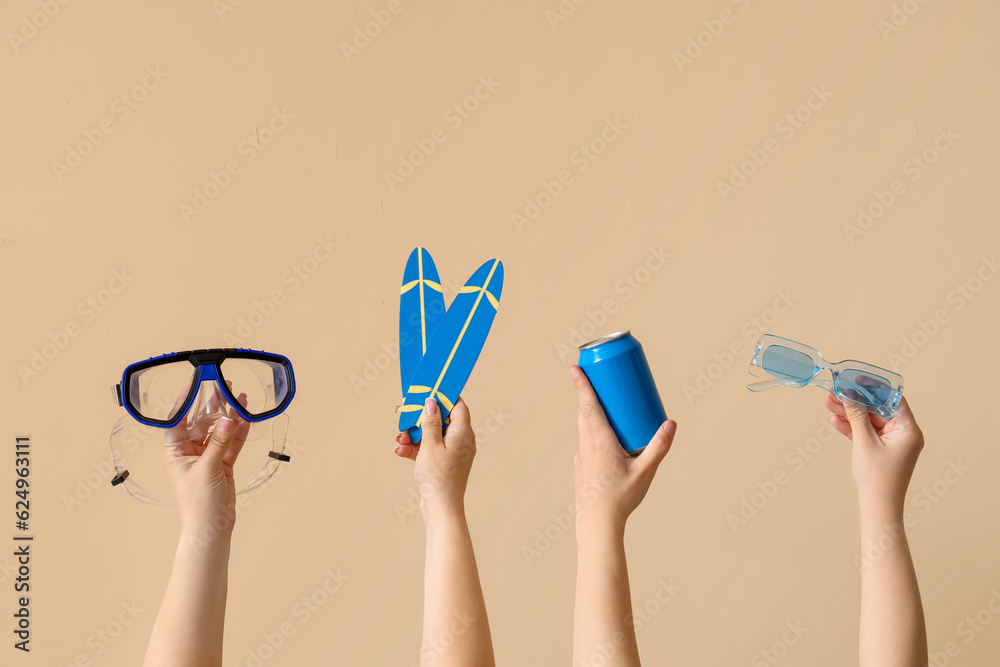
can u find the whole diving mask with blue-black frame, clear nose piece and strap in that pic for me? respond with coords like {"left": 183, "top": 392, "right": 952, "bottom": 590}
{"left": 111, "top": 348, "right": 295, "bottom": 505}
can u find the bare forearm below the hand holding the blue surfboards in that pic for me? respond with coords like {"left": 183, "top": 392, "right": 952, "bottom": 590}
{"left": 420, "top": 509, "right": 495, "bottom": 667}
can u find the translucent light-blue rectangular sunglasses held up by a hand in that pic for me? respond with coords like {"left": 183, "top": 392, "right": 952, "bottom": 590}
{"left": 747, "top": 334, "right": 903, "bottom": 419}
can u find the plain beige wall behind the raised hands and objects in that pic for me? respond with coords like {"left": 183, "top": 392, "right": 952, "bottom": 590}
{"left": 0, "top": 0, "right": 1000, "bottom": 667}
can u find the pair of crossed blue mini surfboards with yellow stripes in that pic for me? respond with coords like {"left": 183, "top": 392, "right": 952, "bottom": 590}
{"left": 399, "top": 248, "right": 503, "bottom": 442}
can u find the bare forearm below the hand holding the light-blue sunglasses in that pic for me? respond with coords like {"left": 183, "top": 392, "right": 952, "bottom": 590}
{"left": 860, "top": 498, "right": 927, "bottom": 667}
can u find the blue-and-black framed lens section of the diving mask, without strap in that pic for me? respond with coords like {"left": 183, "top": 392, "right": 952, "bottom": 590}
{"left": 115, "top": 348, "right": 295, "bottom": 428}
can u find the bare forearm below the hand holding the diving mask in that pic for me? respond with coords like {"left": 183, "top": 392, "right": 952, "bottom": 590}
{"left": 143, "top": 532, "right": 231, "bottom": 667}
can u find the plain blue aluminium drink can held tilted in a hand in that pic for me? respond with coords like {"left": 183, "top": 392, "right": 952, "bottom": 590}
{"left": 579, "top": 331, "right": 667, "bottom": 456}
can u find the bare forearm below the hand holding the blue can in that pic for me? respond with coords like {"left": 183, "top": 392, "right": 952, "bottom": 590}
{"left": 573, "top": 521, "right": 639, "bottom": 667}
